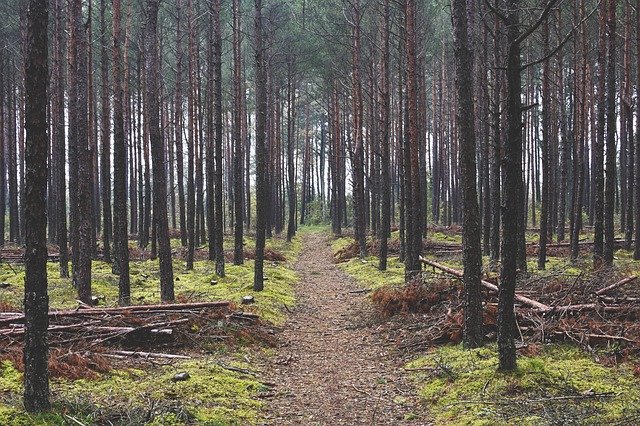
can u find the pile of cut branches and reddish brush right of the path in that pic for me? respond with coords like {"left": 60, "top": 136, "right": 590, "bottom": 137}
{"left": 372, "top": 259, "right": 640, "bottom": 361}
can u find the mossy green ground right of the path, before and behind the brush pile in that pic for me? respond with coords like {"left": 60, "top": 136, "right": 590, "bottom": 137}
{"left": 333, "top": 234, "right": 640, "bottom": 425}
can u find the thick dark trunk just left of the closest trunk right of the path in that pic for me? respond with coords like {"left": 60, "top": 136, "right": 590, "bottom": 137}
{"left": 451, "top": 0, "right": 484, "bottom": 348}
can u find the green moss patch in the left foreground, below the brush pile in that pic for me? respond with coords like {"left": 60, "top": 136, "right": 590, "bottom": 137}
{"left": 0, "top": 359, "right": 265, "bottom": 426}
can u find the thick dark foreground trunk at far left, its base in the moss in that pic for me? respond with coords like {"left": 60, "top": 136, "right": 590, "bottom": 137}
{"left": 23, "top": 0, "right": 51, "bottom": 412}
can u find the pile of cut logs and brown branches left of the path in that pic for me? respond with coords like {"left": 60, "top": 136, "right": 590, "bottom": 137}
{"left": 0, "top": 301, "right": 270, "bottom": 379}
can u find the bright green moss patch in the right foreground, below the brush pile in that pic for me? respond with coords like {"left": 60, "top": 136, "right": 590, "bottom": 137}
{"left": 407, "top": 346, "right": 640, "bottom": 425}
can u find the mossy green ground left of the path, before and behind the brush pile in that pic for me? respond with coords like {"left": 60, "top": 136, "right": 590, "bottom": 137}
{"left": 0, "top": 238, "right": 302, "bottom": 425}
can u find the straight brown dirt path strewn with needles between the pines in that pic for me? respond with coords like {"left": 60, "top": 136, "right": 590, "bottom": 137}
{"left": 264, "top": 234, "right": 428, "bottom": 425}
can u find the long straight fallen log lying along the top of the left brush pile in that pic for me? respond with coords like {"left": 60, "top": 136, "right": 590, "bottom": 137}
{"left": 0, "top": 301, "right": 231, "bottom": 325}
